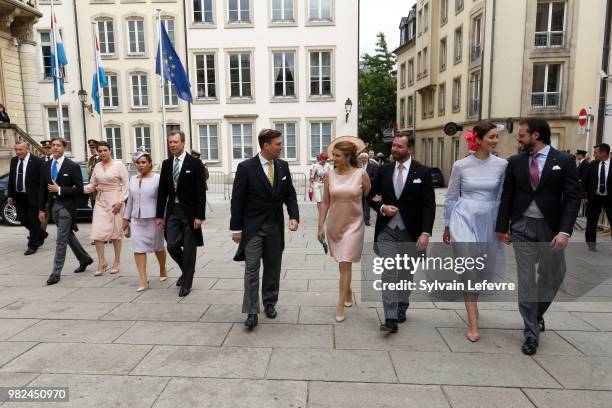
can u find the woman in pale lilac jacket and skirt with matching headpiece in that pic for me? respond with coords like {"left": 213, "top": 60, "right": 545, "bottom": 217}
{"left": 123, "top": 152, "right": 167, "bottom": 292}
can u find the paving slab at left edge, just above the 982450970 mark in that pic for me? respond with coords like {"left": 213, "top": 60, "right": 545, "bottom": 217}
{"left": 2, "top": 343, "right": 151, "bottom": 374}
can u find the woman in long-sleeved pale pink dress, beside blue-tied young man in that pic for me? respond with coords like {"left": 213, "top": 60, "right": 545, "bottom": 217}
{"left": 84, "top": 142, "right": 130, "bottom": 276}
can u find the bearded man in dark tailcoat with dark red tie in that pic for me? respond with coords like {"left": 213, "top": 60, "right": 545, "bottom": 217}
{"left": 495, "top": 118, "right": 580, "bottom": 355}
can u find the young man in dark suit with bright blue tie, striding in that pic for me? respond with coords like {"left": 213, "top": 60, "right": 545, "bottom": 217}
{"left": 38, "top": 137, "right": 93, "bottom": 285}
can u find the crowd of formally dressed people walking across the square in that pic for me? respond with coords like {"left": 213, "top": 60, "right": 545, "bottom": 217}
{"left": 9, "top": 118, "right": 612, "bottom": 354}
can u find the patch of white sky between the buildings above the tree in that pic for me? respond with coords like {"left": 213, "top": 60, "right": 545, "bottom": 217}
{"left": 359, "top": 0, "right": 415, "bottom": 55}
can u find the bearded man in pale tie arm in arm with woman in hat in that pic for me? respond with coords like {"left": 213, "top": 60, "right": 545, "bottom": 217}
{"left": 368, "top": 135, "right": 436, "bottom": 333}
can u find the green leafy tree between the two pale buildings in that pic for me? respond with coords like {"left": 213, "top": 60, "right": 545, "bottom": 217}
{"left": 359, "top": 33, "right": 397, "bottom": 151}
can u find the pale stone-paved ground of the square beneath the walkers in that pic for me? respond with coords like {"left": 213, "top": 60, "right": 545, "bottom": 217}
{"left": 0, "top": 190, "right": 612, "bottom": 408}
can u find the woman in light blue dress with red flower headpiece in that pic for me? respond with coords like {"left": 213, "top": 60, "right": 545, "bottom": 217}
{"left": 443, "top": 122, "right": 507, "bottom": 342}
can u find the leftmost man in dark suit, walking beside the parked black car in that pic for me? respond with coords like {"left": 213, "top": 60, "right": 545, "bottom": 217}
{"left": 7, "top": 142, "right": 46, "bottom": 255}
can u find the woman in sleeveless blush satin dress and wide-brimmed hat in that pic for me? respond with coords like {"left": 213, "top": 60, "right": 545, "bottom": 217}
{"left": 317, "top": 137, "right": 371, "bottom": 322}
